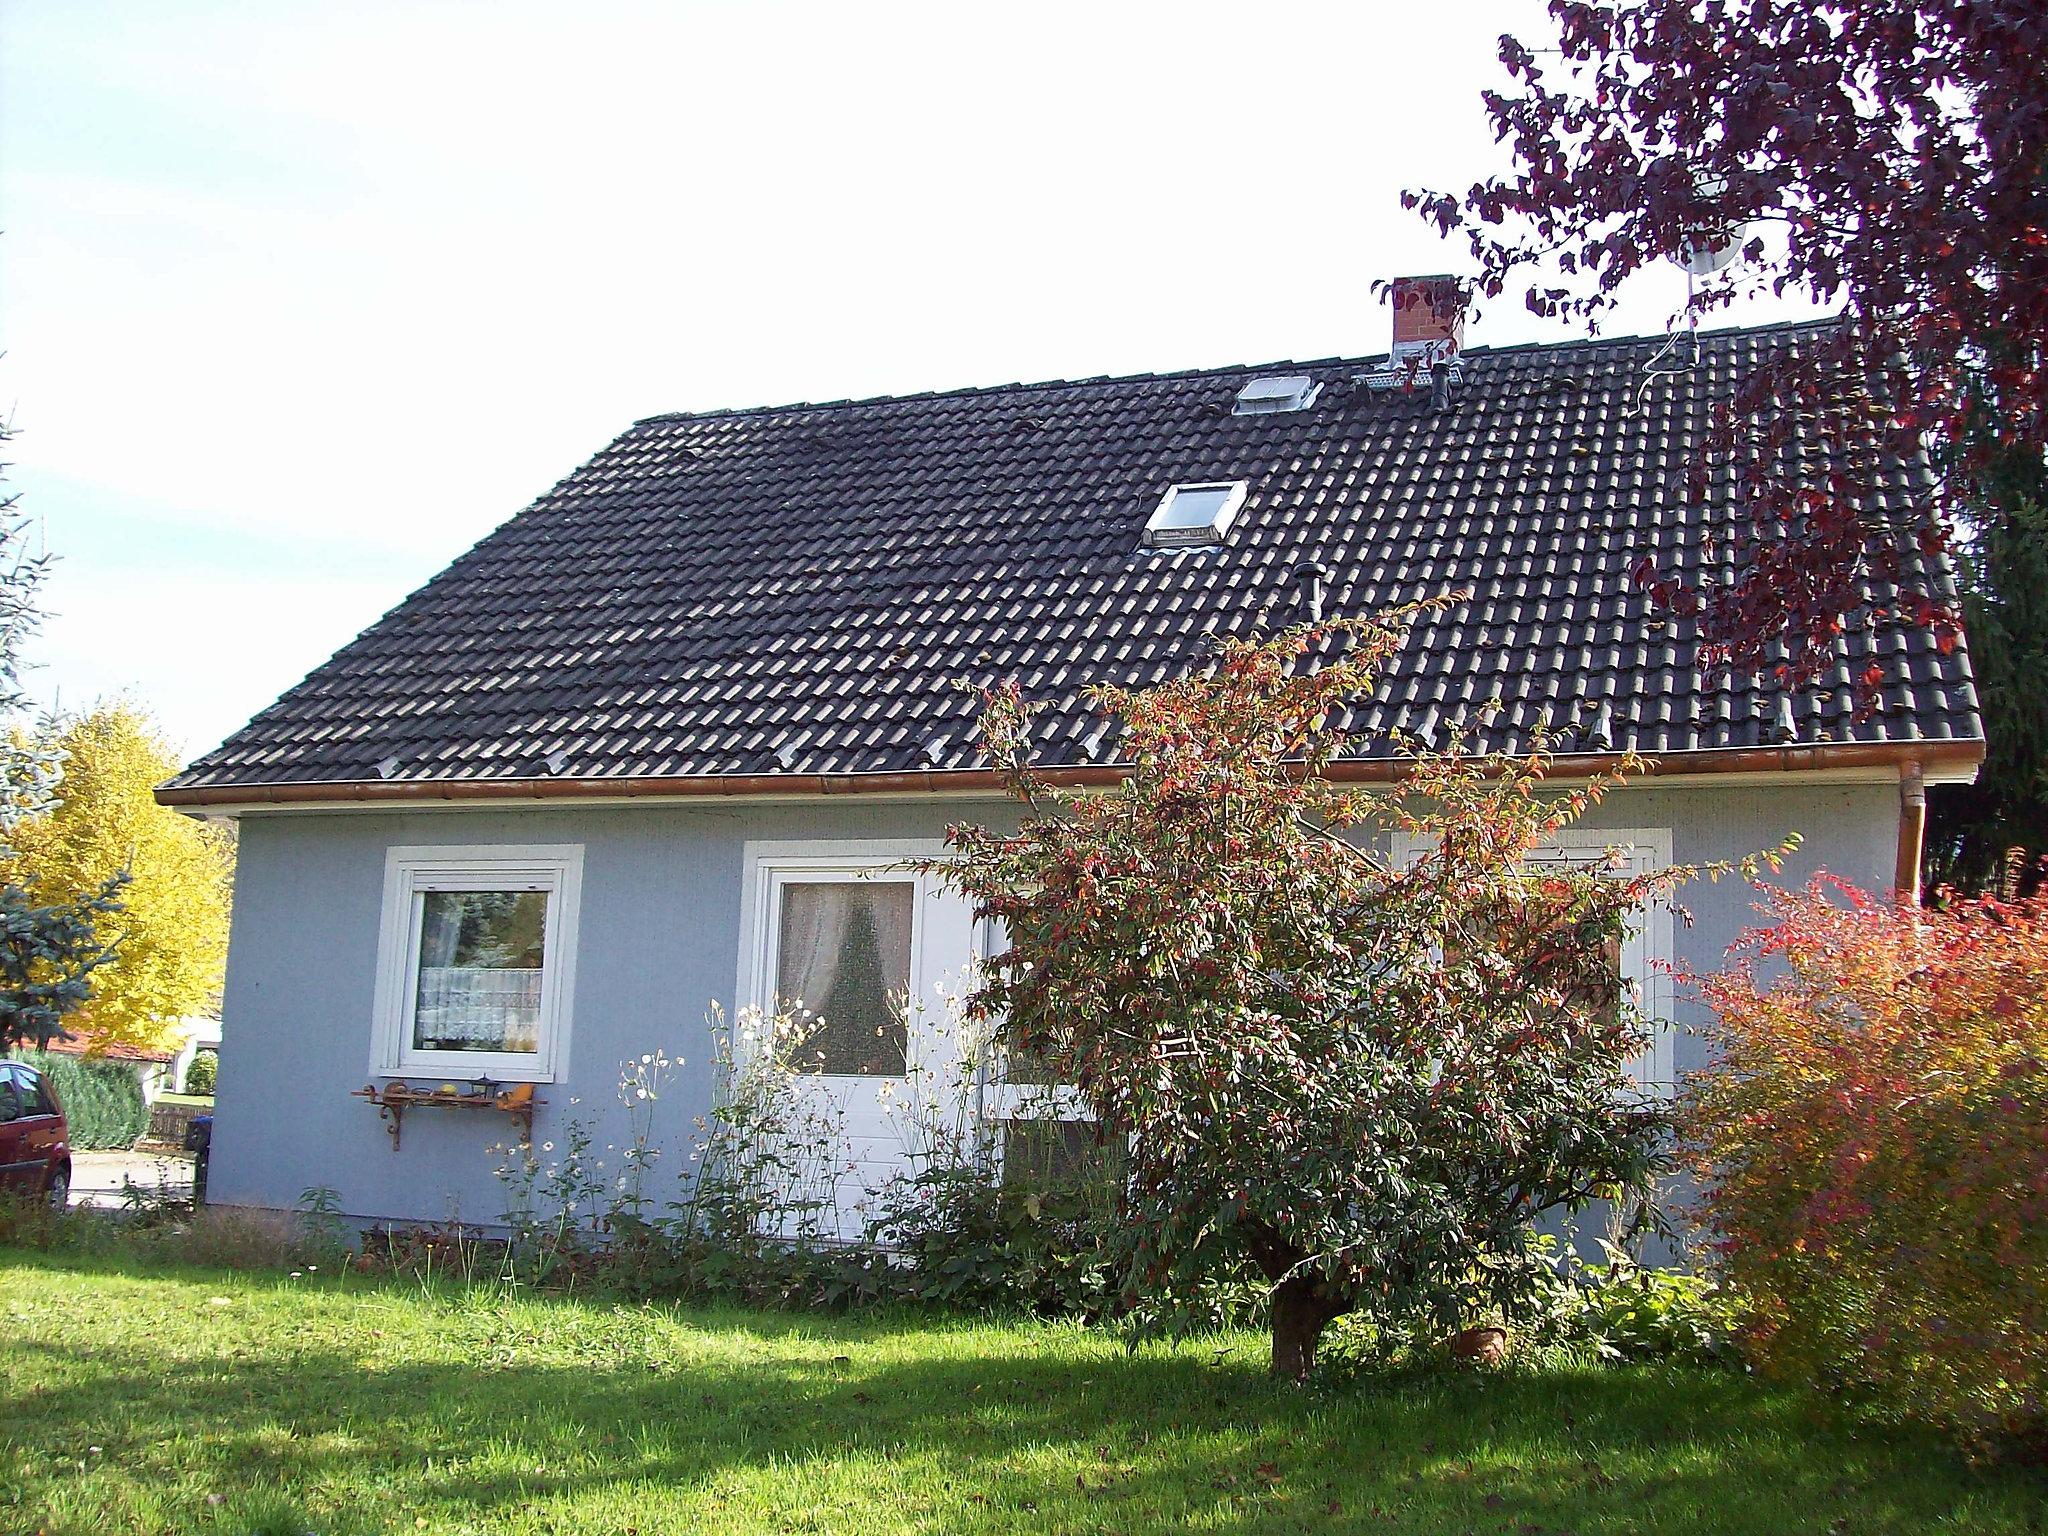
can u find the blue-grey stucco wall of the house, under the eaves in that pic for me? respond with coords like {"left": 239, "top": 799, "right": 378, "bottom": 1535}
{"left": 211, "top": 784, "right": 1896, "bottom": 1223}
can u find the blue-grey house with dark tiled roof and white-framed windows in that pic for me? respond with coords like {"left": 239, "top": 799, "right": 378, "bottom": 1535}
{"left": 160, "top": 301, "right": 1982, "bottom": 1221}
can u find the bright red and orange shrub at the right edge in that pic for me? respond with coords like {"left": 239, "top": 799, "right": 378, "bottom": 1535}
{"left": 1688, "top": 879, "right": 2048, "bottom": 1432}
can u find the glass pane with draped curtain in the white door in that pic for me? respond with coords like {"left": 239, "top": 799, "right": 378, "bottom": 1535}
{"left": 774, "top": 881, "right": 915, "bottom": 1077}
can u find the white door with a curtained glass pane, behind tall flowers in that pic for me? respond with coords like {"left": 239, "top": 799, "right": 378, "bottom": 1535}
{"left": 739, "top": 842, "right": 975, "bottom": 1237}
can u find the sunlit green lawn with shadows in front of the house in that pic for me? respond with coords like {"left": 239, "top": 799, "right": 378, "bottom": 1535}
{"left": 0, "top": 1249, "right": 2048, "bottom": 1536}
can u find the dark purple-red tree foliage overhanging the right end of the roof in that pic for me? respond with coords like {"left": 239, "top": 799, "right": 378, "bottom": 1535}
{"left": 1405, "top": 0, "right": 2048, "bottom": 698}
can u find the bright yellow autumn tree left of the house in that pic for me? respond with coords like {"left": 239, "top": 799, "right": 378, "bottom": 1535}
{"left": 10, "top": 698, "right": 236, "bottom": 1047}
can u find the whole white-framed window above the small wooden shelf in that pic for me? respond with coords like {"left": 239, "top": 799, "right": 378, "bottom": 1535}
{"left": 371, "top": 844, "right": 584, "bottom": 1083}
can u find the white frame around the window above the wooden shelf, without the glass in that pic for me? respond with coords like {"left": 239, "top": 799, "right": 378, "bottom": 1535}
{"left": 371, "top": 844, "right": 584, "bottom": 1083}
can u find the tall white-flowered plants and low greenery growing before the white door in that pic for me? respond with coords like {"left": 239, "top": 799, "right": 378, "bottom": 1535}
{"left": 446, "top": 1024, "right": 1155, "bottom": 1319}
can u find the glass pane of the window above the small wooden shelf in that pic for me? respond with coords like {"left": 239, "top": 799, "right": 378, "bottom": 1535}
{"left": 412, "top": 891, "right": 547, "bottom": 1053}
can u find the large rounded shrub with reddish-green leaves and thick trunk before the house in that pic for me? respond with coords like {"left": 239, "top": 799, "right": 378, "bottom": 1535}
{"left": 922, "top": 626, "right": 1744, "bottom": 1378}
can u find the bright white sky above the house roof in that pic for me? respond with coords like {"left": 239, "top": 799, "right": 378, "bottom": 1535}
{"left": 0, "top": 0, "right": 1826, "bottom": 754}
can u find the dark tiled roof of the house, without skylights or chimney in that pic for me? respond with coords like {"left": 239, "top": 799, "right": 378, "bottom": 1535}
{"left": 172, "top": 313, "right": 1980, "bottom": 786}
